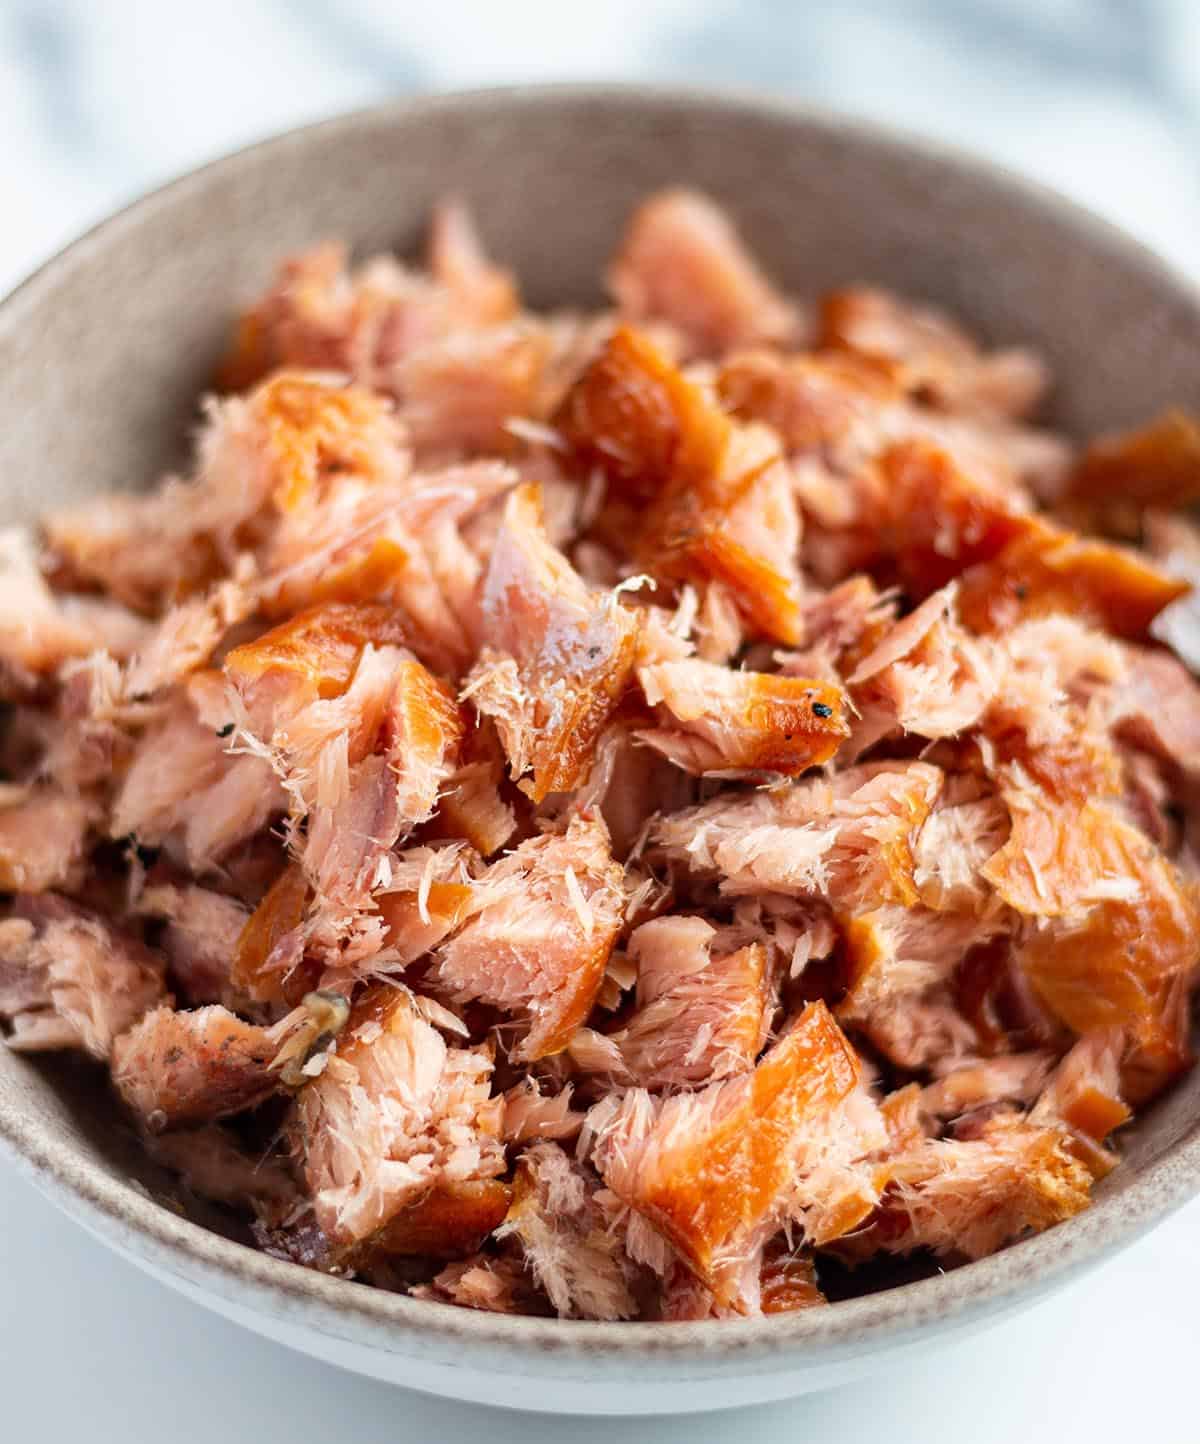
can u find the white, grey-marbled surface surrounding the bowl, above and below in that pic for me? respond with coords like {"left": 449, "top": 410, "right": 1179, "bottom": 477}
{"left": 0, "top": 0, "right": 1200, "bottom": 1444}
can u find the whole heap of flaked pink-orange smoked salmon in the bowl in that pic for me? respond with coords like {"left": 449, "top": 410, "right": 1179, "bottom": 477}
{"left": 0, "top": 191, "right": 1200, "bottom": 1320}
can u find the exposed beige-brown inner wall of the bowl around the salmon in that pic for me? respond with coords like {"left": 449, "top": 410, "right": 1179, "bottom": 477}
{"left": 0, "top": 90, "right": 1200, "bottom": 1351}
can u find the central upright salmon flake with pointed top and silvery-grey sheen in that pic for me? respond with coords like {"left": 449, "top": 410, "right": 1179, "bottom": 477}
{"left": 464, "top": 487, "right": 637, "bottom": 801}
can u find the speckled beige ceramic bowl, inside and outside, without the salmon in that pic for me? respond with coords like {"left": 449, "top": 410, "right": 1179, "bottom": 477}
{"left": 0, "top": 88, "right": 1200, "bottom": 1414}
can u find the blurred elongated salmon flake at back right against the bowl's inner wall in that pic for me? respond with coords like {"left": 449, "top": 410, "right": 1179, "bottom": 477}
{"left": 817, "top": 286, "right": 1048, "bottom": 417}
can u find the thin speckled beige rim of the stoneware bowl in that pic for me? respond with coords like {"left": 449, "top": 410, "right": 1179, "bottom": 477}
{"left": 0, "top": 82, "right": 1200, "bottom": 1378}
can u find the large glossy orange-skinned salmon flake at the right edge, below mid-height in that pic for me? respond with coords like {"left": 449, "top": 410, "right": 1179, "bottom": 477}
{"left": 1018, "top": 806, "right": 1200, "bottom": 1062}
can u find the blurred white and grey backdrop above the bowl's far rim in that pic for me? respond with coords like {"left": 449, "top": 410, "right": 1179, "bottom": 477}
{"left": 0, "top": 0, "right": 1200, "bottom": 296}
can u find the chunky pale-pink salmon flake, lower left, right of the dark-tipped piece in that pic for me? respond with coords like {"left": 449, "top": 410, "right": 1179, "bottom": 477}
{"left": 290, "top": 985, "right": 504, "bottom": 1245}
